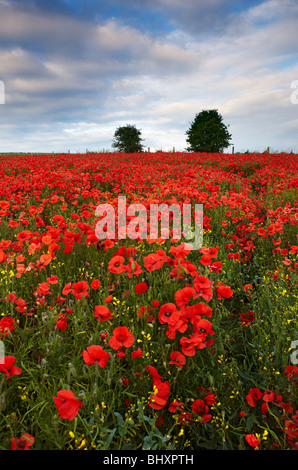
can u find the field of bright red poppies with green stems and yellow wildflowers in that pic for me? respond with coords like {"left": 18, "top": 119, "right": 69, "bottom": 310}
{"left": 0, "top": 152, "right": 298, "bottom": 451}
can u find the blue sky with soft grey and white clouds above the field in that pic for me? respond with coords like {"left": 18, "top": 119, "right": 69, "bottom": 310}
{"left": 0, "top": 0, "right": 298, "bottom": 153}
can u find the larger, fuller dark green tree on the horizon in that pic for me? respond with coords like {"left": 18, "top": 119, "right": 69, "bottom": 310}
{"left": 186, "top": 109, "right": 232, "bottom": 153}
